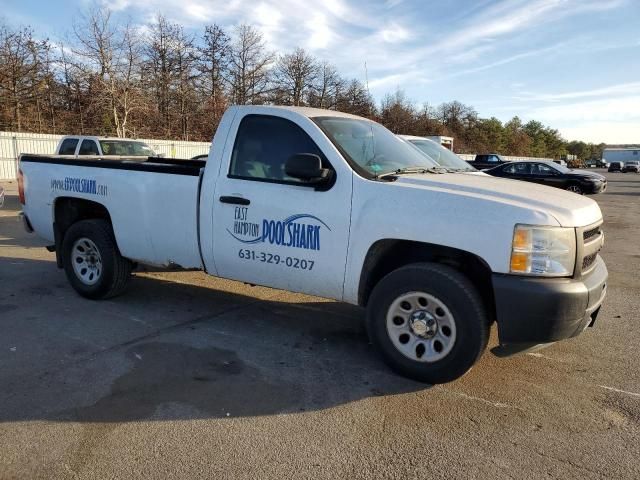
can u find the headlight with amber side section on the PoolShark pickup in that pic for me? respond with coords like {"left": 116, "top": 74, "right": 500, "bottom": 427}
{"left": 510, "top": 225, "right": 576, "bottom": 277}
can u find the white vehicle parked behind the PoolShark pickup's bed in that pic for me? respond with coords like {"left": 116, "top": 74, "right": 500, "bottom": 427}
{"left": 56, "top": 135, "right": 156, "bottom": 157}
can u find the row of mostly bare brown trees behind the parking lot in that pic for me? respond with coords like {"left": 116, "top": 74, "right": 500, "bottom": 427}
{"left": 0, "top": 7, "right": 603, "bottom": 159}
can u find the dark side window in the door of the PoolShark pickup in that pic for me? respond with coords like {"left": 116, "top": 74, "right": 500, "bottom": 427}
{"left": 229, "top": 115, "right": 329, "bottom": 183}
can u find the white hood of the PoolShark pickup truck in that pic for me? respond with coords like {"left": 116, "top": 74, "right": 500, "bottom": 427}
{"left": 395, "top": 173, "right": 602, "bottom": 227}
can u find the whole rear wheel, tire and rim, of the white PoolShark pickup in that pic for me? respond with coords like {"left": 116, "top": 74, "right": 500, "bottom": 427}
{"left": 62, "top": 219, "right": 132, "bottom": 299}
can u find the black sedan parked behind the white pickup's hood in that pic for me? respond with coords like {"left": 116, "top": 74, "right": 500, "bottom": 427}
{"left": 486, "top": 160, "right": 607, "bottom": 194}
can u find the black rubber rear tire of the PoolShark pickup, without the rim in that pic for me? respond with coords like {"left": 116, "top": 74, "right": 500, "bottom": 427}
{"left": 62, "top": 219, "right": 132, "bottom": 300}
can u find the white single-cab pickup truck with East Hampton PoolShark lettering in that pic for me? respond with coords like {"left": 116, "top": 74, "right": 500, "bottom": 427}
{"left": 19, "top": 106, "right": 607, "bottom": 383}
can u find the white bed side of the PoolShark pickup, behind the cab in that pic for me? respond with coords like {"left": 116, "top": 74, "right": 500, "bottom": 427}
{"left": 20, "top": 155, "right": 206, "bottom": 268}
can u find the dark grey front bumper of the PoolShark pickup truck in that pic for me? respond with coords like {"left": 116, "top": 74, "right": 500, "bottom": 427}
{"left": 493, "top": 256, "right": 609, "bottom": 353}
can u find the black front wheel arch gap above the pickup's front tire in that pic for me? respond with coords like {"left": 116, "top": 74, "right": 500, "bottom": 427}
{"left": 358, "top": 239, "right": 495, "bottom": 319}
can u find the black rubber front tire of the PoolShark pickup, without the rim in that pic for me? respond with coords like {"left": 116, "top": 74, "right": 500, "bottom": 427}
{"left": 367, "top": 263, "right": 490, "bottom": 384}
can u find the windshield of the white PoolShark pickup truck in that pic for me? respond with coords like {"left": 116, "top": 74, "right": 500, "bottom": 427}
{"left": 313, "top": 117, "right": 438, "bottom": 176}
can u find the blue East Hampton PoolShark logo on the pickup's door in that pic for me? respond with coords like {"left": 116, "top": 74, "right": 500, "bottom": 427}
{"left": 227, "top": 207, "right": 331, "bottom": 250}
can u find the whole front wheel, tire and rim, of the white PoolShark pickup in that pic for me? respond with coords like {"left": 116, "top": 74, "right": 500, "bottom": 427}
{"left": 367, "top": 263, "right": 489, "bottom": 384}
